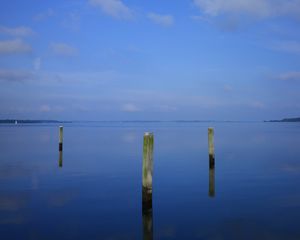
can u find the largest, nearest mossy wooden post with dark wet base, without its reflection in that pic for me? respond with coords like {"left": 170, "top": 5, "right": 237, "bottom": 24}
{"left": 142, "top": 132, "right": 154, "bottom": 209}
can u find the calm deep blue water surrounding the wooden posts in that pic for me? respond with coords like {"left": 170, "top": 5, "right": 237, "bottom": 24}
{"left": 0, "top": 123, "right": 300, "bottom": 240}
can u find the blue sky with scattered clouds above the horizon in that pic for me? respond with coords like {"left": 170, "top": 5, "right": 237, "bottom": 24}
{"left": 0, "top": 0, "right": 300, "bottom": 120}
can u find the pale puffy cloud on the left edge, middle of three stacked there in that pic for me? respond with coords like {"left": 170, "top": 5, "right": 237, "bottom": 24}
{"left": 0, "top": 39, "right": 32, "bottom": 54}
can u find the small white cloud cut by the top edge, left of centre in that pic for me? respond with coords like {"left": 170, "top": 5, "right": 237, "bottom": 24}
{"left": 89, "top": 0, "right": 133, "bottom": 19}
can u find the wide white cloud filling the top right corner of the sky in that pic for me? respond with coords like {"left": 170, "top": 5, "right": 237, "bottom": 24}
{"left": 194, "top": 0, "right": 300, "bottom": 17}
